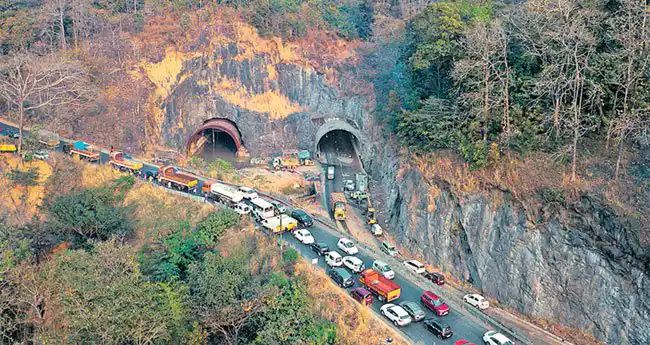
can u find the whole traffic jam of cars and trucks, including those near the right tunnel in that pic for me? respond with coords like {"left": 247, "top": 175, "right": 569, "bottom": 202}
{"left": 0, "top": 127, "right": 514, "bottom": 345}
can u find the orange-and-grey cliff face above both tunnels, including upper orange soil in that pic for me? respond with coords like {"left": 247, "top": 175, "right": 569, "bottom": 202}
{"left": 135, "top": 23, "right": 367, "bottom": 156}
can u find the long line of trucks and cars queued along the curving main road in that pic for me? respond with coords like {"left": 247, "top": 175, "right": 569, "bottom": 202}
{"left": 6, "top": 127, "right": 513, "bottom": 345}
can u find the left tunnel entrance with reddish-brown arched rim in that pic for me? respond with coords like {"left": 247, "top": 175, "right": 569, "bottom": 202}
{"left": 187, "top": 118, "right": 248, "bottom": 161}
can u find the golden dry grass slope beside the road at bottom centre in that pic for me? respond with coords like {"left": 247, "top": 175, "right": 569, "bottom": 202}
{"left": 296, "top": 261, "right": 409, "bottom": 344}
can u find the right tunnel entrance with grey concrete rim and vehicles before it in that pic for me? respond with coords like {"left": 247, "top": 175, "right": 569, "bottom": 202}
{"left": 316, "top": 129, "right": 360, "bottom": 166}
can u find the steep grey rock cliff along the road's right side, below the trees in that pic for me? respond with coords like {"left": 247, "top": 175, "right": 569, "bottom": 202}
{"left": 365, "top": 138, "right": 650, "bottom": 344}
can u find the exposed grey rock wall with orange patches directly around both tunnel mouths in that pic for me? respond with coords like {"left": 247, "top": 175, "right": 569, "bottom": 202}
{"left": 159, "top": 43, "right": 366, "bottom": 156}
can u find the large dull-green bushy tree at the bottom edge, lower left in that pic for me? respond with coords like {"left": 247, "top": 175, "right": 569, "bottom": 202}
{"left": 38, "top": 241, "right": 186, "bottom": 344}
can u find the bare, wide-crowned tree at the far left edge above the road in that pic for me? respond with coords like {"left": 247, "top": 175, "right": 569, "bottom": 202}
{"left": 0, "top": 53, "right": 93, "bottom": 153}
